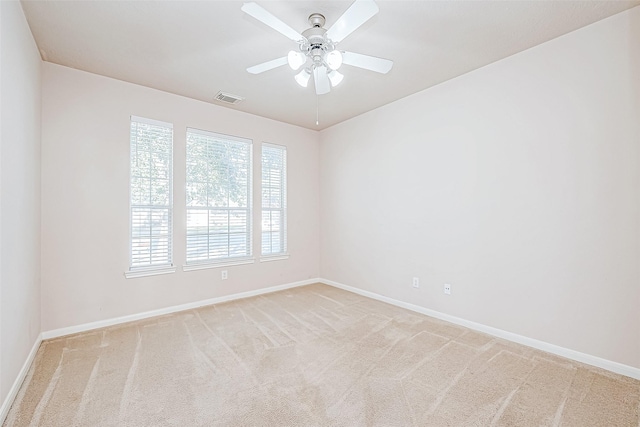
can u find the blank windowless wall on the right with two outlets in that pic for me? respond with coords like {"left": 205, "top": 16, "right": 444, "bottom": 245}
{"left": 320, "top": 7, "right": 640, "bottom": 368}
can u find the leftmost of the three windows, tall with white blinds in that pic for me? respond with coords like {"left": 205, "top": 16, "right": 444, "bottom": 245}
{"left": 127, "top": 116, "right": 173, "bottom": 277}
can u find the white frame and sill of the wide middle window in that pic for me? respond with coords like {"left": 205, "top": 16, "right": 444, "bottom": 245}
{"left": 183, "top": 127, "right": 255, "bottom": 271}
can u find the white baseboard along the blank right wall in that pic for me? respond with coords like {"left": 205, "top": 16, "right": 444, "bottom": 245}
{"left": 319, "top": 279, "right": 640, "bottom": 380}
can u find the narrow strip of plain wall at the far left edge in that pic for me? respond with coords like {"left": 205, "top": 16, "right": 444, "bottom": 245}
{"left": 0, "top": 1, "right": 41, "bottom": 402}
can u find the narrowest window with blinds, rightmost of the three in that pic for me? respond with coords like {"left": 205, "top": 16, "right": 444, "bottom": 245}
{"left": 262, "top": 144, "right": 287, "bottom": 256}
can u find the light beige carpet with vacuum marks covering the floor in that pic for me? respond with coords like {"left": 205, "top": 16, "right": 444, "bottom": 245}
{"left": 5, "top": 284, "right": 640, "bottom": 427}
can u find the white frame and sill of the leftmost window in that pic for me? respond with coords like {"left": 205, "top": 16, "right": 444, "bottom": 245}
{"left": 125, "top": 115, "right": 176, "bottom": 279}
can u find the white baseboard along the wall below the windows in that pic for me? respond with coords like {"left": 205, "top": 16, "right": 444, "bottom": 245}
{"left": 42, "top": 279, "right": 320, "bottom": 340}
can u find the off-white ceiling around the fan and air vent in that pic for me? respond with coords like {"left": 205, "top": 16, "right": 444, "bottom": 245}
{"left": 22, "top": 0, "right": 640, "bottom": 129}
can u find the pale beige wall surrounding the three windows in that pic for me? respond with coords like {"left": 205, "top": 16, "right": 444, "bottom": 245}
{"left": 42, "top": 63, "right": 319, "bottom": 331}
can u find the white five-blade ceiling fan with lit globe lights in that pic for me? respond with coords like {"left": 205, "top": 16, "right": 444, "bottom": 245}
{"left": 241, "top": 0, "right": 393, "bottom": 95}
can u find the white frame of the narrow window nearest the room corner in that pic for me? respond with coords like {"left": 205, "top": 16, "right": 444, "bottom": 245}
{"left": 260, "top": 142, "right": 289, "bottom": 262}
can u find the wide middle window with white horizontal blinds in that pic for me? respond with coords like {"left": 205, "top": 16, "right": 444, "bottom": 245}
{"left": 186, "top": 129, "right": 252, "bottom": 264}
